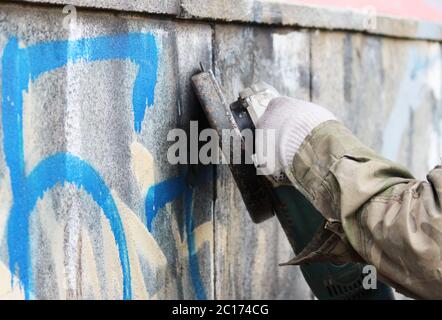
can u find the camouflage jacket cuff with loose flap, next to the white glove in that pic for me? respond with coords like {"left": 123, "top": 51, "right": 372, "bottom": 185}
{"left": 286, "top": 120, "right": 375, "bottom": 264}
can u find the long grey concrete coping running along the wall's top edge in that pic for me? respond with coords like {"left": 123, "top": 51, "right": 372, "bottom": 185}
{"left": 15, "top": 0, "right": 442, "bottom": 41}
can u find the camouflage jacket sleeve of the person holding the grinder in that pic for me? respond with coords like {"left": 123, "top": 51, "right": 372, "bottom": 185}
{"left": 288, "top": 121, "right": 442, "bottom": 299}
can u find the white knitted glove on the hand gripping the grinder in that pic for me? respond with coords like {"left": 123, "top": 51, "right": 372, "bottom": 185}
{"left": 255, "top": 97, "right": 336, "bottom": 175}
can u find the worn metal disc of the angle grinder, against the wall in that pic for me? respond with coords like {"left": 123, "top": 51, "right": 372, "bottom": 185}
{"left": 192, "top": 71, "right": 274, "bottom": 223}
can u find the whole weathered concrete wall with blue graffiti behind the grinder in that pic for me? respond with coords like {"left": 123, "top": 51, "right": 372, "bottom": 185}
{"left": 0, "top": 0, "right": 442, "bottom": 299}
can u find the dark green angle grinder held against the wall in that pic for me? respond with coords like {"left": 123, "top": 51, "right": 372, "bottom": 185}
{"left": 192, "top": 70, "right": 393, "bottom": 300}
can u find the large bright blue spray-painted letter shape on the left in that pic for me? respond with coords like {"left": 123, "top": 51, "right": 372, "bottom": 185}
{"left": 2, "top": 33, "right": 158, "bottom": 299}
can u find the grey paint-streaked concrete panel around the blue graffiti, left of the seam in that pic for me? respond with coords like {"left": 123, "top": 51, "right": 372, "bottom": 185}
{"left": 0, "top": 5, "right": 213, "bottom": 299}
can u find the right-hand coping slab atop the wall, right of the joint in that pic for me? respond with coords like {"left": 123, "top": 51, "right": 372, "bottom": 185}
{"left": 181, "top": 0, "right": 442, "bottom": 40}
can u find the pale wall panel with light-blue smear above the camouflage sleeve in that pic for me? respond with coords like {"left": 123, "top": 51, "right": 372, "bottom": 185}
{"left": 312, "top": 32, "right": 442, "bottom": 179}
